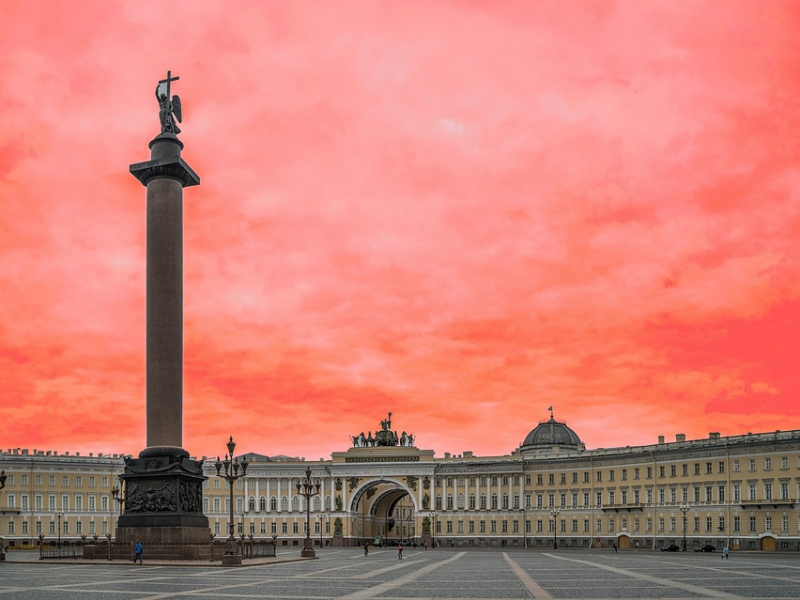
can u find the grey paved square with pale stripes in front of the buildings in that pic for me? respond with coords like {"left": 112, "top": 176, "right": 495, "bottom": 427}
{"left": 0, "top": 548, "right": 800, "bottom": 600}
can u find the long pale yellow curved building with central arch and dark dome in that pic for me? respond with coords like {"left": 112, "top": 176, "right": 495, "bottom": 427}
{"left": 0, "top": 415, "right": 800, "bottom": 551}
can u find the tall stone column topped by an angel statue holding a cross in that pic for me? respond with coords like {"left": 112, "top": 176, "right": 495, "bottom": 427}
{"left": 117, "top": 71, "right": 209, "bottom": 547}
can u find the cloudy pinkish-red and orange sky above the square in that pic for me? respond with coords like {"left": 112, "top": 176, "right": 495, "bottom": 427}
{"left": 0, "top": 0, "right": 800, "bottom": 459}
